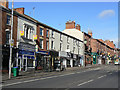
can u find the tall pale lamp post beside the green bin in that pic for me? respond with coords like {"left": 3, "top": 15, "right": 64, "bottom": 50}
{"left": 9, "top": 0, "right": 14, "bottom": 79}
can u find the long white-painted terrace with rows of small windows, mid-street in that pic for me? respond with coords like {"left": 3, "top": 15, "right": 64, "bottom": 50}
{"left": 49, "top": 26, "right": 84, "bottom": 67}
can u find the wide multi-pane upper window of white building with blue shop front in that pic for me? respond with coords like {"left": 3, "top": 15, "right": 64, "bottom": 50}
{"left": 24, "top": 24, "right": 34, "bottom": 39}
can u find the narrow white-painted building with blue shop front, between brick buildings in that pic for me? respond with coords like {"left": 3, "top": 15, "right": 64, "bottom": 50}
{"left": 16, "top": 15, "right": 37, "bottom": 71}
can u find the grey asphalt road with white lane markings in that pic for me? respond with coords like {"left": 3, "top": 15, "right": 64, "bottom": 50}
{"left": 2, "top": 65, "right": 119, "bottom": 88}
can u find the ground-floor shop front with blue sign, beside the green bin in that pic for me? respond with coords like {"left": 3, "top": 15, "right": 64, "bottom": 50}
{"left": 17, "top": 43, "right": 36, "bottom": 71}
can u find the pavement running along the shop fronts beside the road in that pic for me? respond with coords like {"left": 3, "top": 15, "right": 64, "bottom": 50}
{"left": 2, "top": 65, "right": 99, "bottom": 82}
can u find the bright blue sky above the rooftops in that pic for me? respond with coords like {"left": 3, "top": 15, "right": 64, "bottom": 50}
{"left": 9, "top": 2, "right": 118, "bottom": 47}
